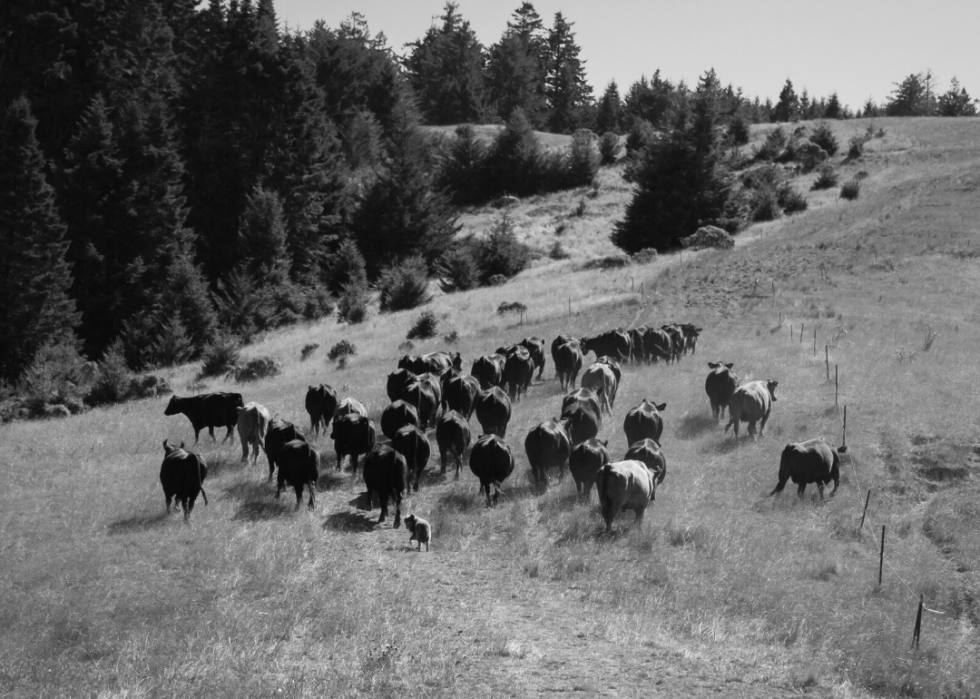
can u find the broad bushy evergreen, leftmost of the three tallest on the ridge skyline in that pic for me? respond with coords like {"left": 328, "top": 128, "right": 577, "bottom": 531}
{"left": 405, "top": 2, "right": 486, "bottom": 124}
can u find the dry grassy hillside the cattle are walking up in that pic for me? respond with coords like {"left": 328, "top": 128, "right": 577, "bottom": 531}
{"left": 0, "top": 119, "right": 980, "bottom": 697}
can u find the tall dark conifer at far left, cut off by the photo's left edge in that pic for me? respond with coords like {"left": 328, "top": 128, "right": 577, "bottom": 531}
{"left": 0, "top": 97, "right": 79, "bottom": 380}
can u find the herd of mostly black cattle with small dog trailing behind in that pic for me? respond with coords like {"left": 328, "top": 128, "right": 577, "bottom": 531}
{"left": 160, "top": 324, "right": 845, "bottom": 536}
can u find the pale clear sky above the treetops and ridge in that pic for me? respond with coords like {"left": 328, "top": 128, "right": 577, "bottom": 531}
{"left": 274, "top": 0, "right": 980, "bottom": 110}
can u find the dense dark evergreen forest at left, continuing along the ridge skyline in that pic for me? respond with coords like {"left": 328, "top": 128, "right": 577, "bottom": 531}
{"left": 0, "top": 0, "right": 974, "bottom": 392}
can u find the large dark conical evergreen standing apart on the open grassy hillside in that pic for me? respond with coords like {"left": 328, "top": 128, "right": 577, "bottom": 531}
{"left": 610, "top": 71, "right": 739, "bottom": 254}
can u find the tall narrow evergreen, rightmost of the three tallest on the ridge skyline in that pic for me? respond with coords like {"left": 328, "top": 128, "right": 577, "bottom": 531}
{"left": 545, "top": 12, "right": 593, "bottom": 133}
